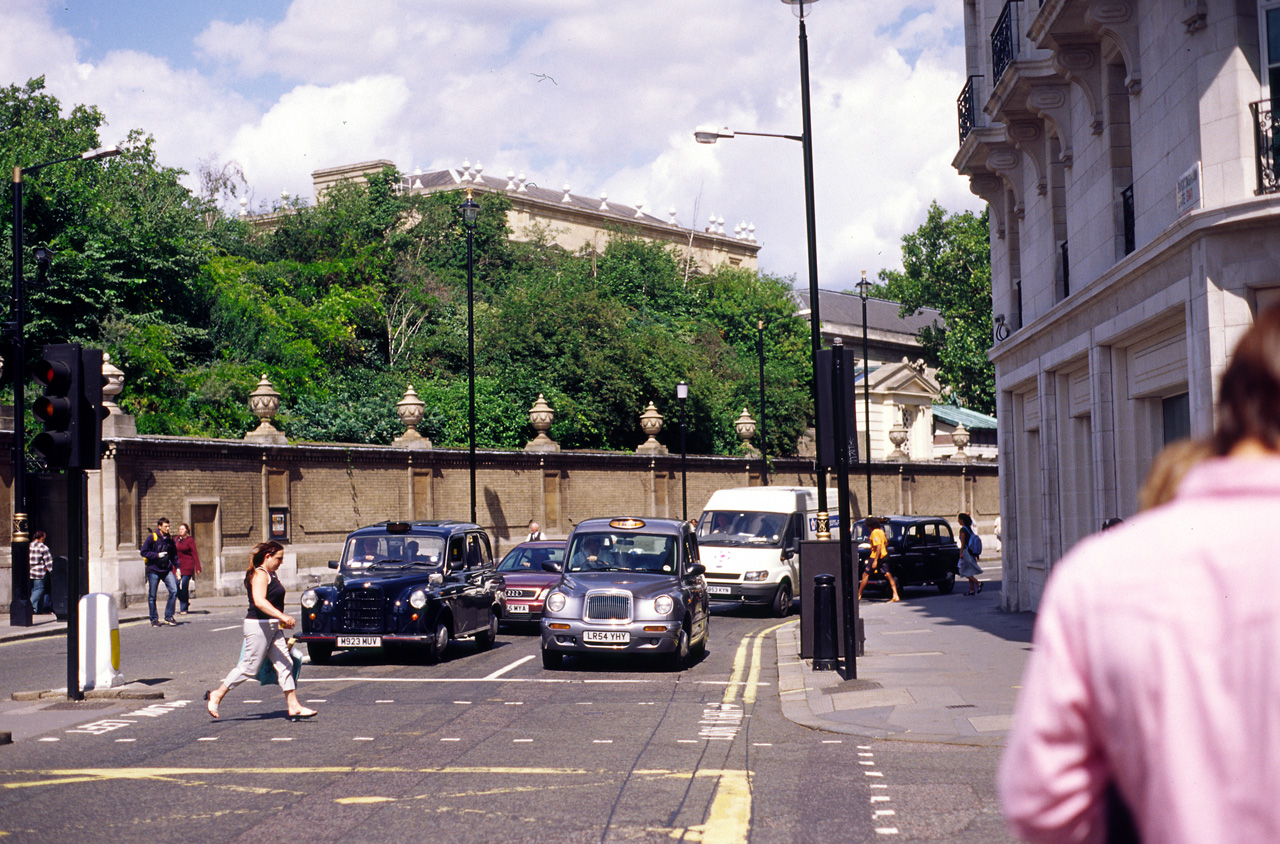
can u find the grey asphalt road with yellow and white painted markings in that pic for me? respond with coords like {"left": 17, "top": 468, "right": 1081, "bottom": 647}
{"left": 0, "top": 610, "right": 1009, "bottom": 844}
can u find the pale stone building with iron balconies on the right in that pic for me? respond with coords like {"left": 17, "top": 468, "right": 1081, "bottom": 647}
{"left": 954, "top": 0, "right": 1280, "bottom": 610}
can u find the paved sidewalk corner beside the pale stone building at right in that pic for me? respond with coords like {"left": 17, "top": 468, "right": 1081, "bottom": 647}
{"left": 777, "top": 580, "right": 1036, "bottom": 747}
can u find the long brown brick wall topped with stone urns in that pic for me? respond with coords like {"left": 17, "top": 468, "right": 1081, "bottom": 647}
{"left": 0, "top": 433, "right": 998, "bottom": 605}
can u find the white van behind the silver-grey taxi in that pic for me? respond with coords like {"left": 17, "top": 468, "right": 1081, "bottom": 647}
{"left": 698, "top": 487, "right": 840, "bottom": 616}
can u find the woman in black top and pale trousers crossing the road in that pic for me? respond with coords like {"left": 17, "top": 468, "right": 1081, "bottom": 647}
{"left": 205, "top": 542, "right": 316, "bottom": 721}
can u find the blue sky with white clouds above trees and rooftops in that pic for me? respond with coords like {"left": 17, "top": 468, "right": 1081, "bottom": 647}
{"left": 0, "top": 0, "right": 980, "bottom": 289}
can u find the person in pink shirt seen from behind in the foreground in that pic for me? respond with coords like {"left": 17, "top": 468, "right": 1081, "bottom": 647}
{"left": 1000, "top": 306, "right": 1280, "bottom": 844}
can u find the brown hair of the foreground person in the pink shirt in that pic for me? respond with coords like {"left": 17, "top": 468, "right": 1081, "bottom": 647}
{"left": 1213, "top": 304, "right": 1280, "bottom": 455}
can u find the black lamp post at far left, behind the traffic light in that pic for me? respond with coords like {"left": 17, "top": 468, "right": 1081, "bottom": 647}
{"left": 4, "top": 146, "right": 120, "bottom": 628}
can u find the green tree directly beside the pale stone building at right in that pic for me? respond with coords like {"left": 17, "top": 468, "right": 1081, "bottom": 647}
{"left": 877, "top": 202, "right": 996, "bottom": 414}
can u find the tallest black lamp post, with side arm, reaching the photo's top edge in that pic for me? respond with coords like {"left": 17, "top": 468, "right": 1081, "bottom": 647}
{"left": 694, "top": 0, "right": 831, "bottom": 539}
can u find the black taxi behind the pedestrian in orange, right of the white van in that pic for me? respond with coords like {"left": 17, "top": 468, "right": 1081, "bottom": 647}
{"left": 852, "top": 516, "right": 960, "bottom": 594}
